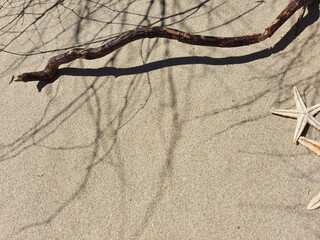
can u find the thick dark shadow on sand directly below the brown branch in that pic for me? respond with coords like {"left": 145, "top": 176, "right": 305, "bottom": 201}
{"left": 37, "top": 0, "right": 320, "bottom": 92}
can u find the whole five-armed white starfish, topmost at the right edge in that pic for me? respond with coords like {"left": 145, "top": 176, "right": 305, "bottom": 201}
{"left": 271, "top": 86, "right": 320, "bottom": 142}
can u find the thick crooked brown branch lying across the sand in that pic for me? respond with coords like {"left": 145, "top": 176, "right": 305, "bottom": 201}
{"left": 12, "top": 0, "right": 314, "bottom": 82}
